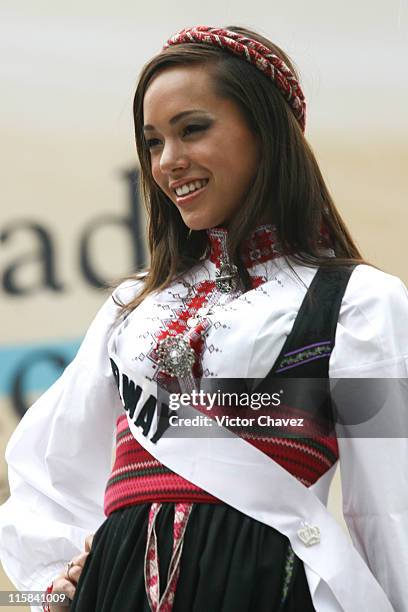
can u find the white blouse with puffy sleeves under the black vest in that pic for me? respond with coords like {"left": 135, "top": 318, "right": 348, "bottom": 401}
{"left": 0, "top": 258, "right": 408, "bottom": 612}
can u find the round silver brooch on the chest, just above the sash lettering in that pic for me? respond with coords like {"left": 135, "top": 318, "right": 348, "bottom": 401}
{"left": 157, "top": 334, "right": 195, "bottom": 377}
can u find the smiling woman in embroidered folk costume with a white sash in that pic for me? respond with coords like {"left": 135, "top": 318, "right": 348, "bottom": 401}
{"left": 1, "top": 26, "right": 408, "bottom": 612}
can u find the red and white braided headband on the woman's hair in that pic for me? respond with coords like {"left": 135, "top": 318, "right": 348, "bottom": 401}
{"left": 163, "top": 26, "right": 306, "bottom": 132}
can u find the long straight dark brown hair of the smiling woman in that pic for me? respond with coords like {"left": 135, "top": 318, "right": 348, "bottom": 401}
{"left": 115, "top": 26, "right": 366, "bottom": 311}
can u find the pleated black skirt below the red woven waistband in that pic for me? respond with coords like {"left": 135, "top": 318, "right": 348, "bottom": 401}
{"left": 70, "top": 503, "right": 315, "bottom": 612}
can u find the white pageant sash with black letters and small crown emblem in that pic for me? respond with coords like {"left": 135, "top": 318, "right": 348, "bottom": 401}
{"left": 114, "top": 355, "right": 394, "bottom": 612}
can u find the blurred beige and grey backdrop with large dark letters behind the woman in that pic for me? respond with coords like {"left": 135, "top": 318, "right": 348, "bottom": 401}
{"left": 0, "top": 0, "right": 408, "bottom": 604}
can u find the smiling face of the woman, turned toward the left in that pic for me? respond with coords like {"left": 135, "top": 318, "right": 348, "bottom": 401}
{"left": 143, "top": 66, "right": 259, "bottom": 230}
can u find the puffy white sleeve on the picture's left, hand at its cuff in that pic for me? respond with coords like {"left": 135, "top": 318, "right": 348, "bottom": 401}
{"left": 0, "top": 281, "right": 140, "bottom": 610}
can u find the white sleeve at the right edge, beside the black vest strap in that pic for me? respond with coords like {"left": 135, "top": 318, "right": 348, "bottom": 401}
{"left": 330, "top": 265, "right": 408, "bottom": 612}
